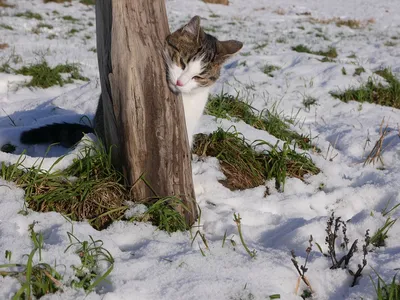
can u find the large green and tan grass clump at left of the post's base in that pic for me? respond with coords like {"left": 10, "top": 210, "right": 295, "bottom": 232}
{"left": 1, "top": 146, "right": 128, "bottom": 229}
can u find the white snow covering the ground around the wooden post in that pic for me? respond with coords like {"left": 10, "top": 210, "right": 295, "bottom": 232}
{"left": 0, "top": 0, "right": 400, "bottom": 300}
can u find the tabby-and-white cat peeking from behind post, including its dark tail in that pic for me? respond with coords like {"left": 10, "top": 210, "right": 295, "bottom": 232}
{"left": 20, "top": 16, "right": 243, "bottom": 148}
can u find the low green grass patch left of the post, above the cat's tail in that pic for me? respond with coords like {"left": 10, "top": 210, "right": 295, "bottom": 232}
{"left": 15, "top": 60, "right": 89, "bottom": 88}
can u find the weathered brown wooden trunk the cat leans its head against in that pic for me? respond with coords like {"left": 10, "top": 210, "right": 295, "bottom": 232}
{"left": 95, "top": 0, "right": 197, "bottom": 225}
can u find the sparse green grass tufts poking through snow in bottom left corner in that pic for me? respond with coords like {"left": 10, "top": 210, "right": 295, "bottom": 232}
{"left": 0, "top": 223, "right": 114, "bottom": 299}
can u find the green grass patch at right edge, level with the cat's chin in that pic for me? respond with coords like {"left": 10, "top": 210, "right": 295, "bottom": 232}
{"left": 330, "top": 68, "right": 400, "bottom": 108}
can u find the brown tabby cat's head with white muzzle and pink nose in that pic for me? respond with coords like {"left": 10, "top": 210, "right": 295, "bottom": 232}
{"left": 165, "top": 16, "right": 243, "bottom": 93}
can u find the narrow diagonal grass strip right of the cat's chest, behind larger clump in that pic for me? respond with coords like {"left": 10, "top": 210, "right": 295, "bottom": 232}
{"left": 206, "top": 93, "right": 314, "bottom": 150}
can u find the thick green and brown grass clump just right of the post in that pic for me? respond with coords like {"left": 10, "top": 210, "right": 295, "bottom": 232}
{"left": 192, "top": 129, "right": 319, "bottom": 190}
